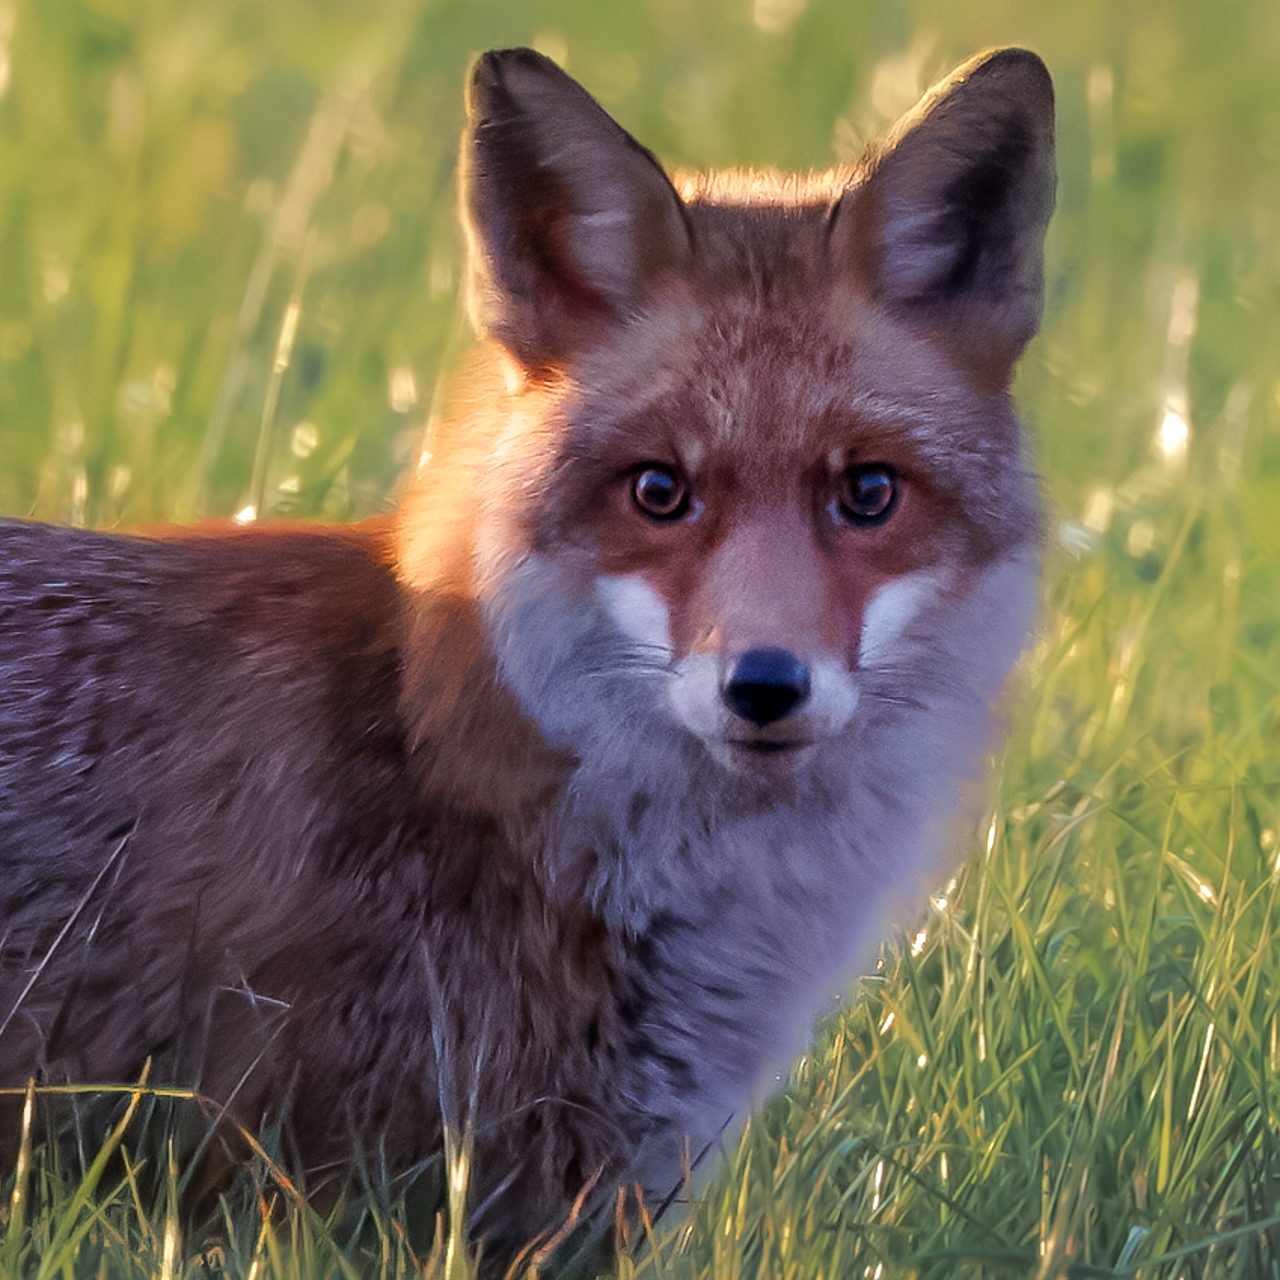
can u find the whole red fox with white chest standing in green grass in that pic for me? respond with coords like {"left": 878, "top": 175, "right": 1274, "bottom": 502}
{"left": 0, "top": 49, "right": 1055, "bottom": 1248}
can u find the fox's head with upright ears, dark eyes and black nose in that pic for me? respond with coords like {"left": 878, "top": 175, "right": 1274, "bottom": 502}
{"left": 396, "top": 49, "right": 1053, "bottom": 819}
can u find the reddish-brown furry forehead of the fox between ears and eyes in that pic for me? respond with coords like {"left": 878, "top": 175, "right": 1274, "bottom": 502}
{"left": 560, "top": 192, "right": 1005, "bottom": 427}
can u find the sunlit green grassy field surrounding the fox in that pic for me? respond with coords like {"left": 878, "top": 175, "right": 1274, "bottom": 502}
{"left": 0, "top": 0, "right": 1280, "bottom": 1280}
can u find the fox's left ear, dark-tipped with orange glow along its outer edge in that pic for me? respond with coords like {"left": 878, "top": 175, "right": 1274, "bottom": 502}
{"left": 462, "top": 49, "right": 690, "bottom": 371}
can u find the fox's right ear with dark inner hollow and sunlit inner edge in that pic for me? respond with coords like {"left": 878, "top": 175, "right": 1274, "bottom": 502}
{"left": 831, "top": 49, "right": 1055, "bottom": 378}
